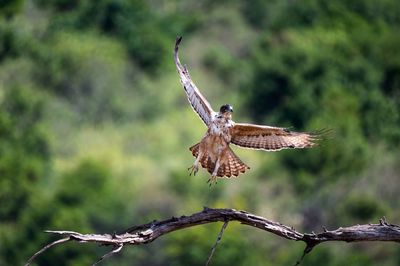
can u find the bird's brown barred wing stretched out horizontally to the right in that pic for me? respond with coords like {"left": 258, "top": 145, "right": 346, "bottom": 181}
{"left": 231, "top": 123, "right": 322, "bottom": 151}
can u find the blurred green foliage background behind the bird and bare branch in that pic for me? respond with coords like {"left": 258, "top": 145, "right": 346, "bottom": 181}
{"left": 0, "top": 0, "right": 400, "bottom": 266}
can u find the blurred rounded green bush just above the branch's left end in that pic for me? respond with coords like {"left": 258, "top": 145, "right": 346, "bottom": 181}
{"left": 53, "top": 159, "right": 128, "bottom": 231}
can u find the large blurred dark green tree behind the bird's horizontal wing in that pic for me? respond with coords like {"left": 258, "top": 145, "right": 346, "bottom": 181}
{"left": 246, "top": 1, "right": 400, "bottom": 193}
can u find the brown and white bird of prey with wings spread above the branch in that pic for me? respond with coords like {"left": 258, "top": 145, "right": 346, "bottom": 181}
{"left": 174, "top": 37, "right": 323, "bottom": 186}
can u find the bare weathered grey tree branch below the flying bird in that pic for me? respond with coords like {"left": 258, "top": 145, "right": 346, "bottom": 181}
{"left": 26, "top": 207, "right": 400, "bottom": 265}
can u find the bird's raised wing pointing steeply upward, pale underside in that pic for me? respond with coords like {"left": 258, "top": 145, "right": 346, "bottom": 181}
{"left": 174, "top": 37, "right": 214, "bottom": 126}
